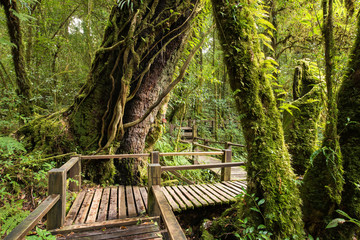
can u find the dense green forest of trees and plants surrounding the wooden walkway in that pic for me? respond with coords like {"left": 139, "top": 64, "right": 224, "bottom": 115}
{"left": 0, "top": 0, "right": 360, "bottom": 240}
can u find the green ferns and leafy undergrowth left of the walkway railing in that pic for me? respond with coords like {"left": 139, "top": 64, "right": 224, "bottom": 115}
{"left": 0, "top": 137, "right": 56, "bottom": 238}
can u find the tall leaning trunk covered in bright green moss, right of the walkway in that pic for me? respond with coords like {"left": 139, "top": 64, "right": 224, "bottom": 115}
{"left": 212, "top": 0, "right": 303, "bottom": 239}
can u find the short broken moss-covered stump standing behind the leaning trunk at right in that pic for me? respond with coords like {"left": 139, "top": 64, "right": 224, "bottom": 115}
{"left": 283, "top": 60, "right": 323, "bottom": 175}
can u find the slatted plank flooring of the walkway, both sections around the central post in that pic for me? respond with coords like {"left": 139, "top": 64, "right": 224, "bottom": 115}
{"left": 64, "top": 181, "right": 246, "bottom": 226}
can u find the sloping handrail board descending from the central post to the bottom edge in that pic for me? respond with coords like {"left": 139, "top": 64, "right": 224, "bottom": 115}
{"left": 151, "top": 186, "right": 186, "bottom": 240}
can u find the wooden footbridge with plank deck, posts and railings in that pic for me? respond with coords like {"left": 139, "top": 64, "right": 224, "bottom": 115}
{"left": 5, "top": 140, "right": 246, "bottom": 240}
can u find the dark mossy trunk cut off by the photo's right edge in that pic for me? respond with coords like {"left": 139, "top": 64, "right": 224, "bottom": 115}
{"left": 337, "top": 11, "right": 360, "bottom": 240}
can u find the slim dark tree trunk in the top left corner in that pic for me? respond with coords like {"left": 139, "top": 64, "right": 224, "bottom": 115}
{"left": 0, "top": 0, "right": 33, "bottom": 117}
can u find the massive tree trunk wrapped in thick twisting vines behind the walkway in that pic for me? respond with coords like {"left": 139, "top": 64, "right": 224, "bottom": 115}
{"left": 20, "top": 0, "right": 202, "bottom": 184}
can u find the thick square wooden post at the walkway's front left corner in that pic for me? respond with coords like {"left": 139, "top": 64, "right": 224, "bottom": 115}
{"left": 46, "top": 168, "right": 66, "bottom": 230}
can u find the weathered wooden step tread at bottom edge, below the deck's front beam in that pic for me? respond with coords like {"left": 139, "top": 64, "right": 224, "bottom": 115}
{"left": 58, "top": 223, "right": 160, "bottom": 240}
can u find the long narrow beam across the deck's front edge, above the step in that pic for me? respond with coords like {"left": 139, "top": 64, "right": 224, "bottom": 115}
{"left": 50, "top": 216, "right": 159, "bottom": 235}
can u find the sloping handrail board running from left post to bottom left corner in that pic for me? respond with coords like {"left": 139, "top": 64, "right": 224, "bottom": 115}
{"left": 4, "top": 194, "right": 60, "bottom": 240}
